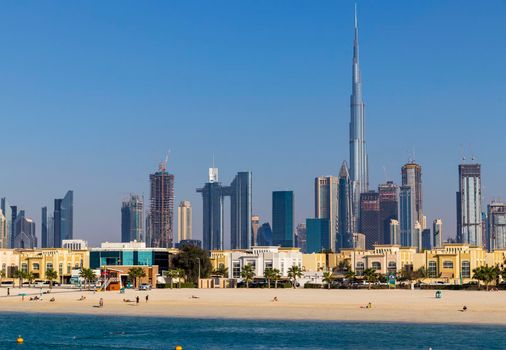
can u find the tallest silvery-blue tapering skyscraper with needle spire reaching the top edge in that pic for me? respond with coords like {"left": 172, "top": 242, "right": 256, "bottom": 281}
{"left": 350, "top": 5, "right": 369, "bottom": 230}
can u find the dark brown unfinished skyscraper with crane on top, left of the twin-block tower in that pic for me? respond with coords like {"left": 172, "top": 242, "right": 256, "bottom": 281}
{"left": 147, "top": 162, "right": 174, "bottom": 248}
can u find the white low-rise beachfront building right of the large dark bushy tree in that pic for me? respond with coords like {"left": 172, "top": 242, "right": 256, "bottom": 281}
{"left": 211, "top": 246, "right": 303, "bottom": 279}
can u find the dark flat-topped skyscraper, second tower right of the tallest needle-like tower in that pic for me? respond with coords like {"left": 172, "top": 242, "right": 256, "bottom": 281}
{"left": 378, "top": 181, "right": 400, "bottom": 244}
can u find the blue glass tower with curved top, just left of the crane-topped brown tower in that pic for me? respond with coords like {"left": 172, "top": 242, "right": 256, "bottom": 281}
{"left": 121, "top": 194, "right": 145, "bottom": 243}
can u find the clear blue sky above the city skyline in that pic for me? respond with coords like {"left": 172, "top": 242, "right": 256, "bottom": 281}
{"left": 0, "top": 0, "right": 506, "bottom": 244}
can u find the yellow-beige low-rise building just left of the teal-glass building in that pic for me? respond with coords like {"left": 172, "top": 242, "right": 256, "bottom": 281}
{"left": 16, "top": 248, "right": 90, "bottom": 283}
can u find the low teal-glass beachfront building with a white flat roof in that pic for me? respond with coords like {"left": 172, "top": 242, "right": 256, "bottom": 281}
{"left": 90, "top": 241, "right": 178, "bottom": 274}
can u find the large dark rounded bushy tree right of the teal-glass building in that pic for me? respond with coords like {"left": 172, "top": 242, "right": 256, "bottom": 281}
{"left": 172, "top": 244, "right": 213, "bottom": 283}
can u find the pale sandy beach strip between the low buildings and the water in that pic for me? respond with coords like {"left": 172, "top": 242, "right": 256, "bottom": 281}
{"left": 0, "top": 288, "right": 506, "bottom": 325}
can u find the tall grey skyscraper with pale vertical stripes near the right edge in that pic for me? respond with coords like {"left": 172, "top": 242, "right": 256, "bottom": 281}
{"left": 457, "top": 164, "right": 483, "bottom": 246}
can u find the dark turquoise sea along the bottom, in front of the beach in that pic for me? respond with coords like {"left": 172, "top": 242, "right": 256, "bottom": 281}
{"left": 0, "top": 313, "right": 506, "bottom": 350}
